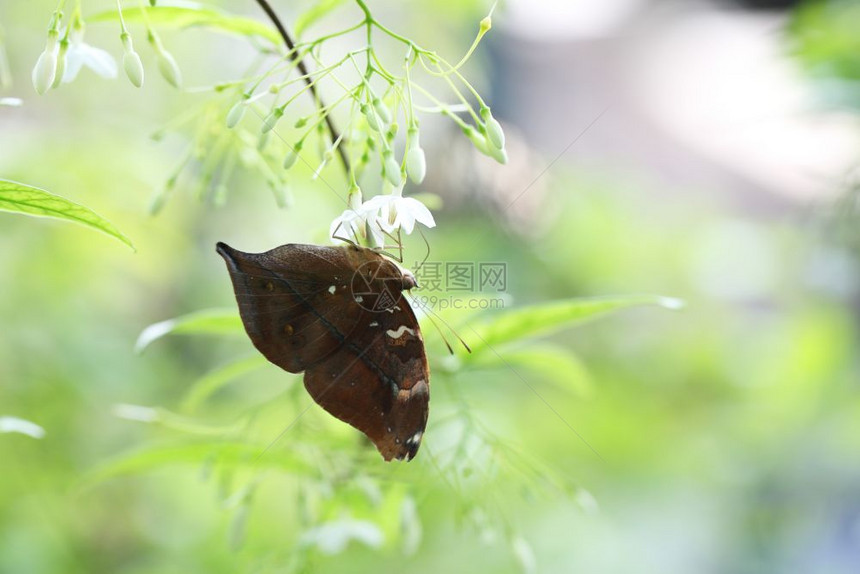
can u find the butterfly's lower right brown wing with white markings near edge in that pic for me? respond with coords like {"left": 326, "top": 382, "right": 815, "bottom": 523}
{"left": 305, "top": 298, "right": 430, "bottom": 460}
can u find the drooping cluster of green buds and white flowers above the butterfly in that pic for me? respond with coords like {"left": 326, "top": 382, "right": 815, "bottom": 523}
{"left": 218, "top": 0, "right": 507, "bottom": 238}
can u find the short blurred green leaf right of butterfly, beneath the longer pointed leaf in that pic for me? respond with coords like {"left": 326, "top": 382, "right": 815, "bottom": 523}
{"left": 463, "top": 344, "right": 592, "bottom": 396}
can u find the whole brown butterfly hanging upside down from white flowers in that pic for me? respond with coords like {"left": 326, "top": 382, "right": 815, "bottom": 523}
{"left": 217, "top": 243, "right": 430, "bottom": 460}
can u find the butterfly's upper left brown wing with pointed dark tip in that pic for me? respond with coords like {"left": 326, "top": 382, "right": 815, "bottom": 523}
{"left": 217, "top": 243, "right": 363, "bottom": 373}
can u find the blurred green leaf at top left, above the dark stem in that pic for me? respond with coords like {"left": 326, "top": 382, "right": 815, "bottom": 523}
{"left": 87, "top": 3, "right": 281, "bottom": 44}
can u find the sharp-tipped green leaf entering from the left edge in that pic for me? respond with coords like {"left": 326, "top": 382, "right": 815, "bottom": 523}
{"left": 0, "top": 179, "right": 134, "bottom": 249}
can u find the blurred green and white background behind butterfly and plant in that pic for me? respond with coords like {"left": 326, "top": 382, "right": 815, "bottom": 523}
{"left": 0, "top": 0, "right": 860, "bottom": 573}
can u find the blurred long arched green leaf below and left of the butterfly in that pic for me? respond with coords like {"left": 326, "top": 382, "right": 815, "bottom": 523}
{"left": 78, "top": 441, "right": 313, "bottom": 490}
